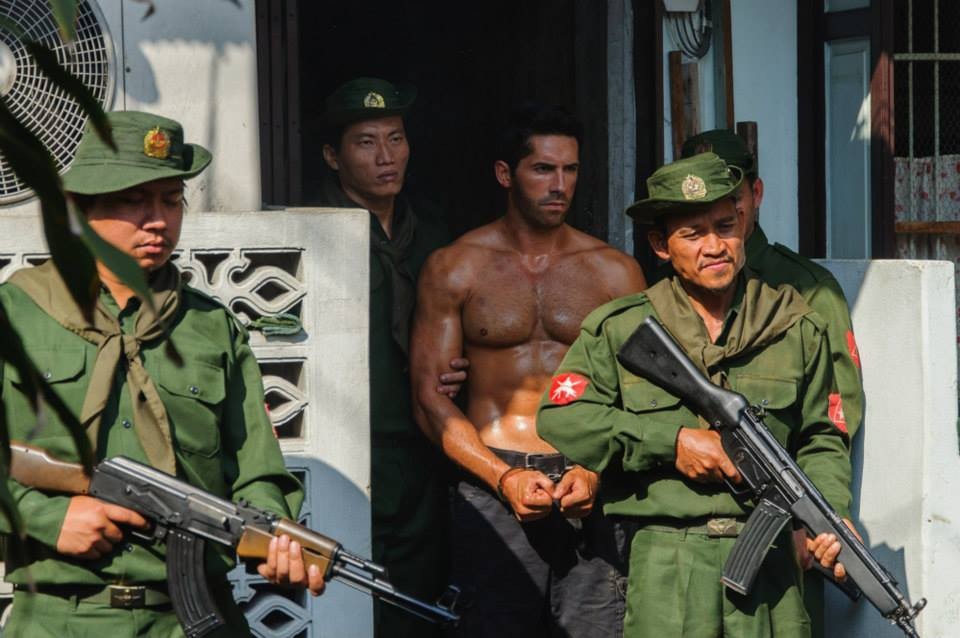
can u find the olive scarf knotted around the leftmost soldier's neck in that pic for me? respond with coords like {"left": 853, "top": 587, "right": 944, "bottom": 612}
{"left": 10, "top": 261, "right": 182, "bottom": 474}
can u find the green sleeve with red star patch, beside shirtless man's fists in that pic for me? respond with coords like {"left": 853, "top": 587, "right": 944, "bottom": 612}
{"left": 537, "top": 330, "right": 680, "bottom": 472}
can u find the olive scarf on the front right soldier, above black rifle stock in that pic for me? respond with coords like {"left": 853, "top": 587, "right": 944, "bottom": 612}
{"left": 645, "top": 272, "right": 810, "bottom": 386}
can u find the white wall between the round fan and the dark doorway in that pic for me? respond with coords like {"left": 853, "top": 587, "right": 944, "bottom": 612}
{"left": 112, "top": 0, "right": 261, "bottom": 212}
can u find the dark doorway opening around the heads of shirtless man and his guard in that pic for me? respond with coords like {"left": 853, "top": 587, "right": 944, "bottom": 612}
{"left": 258, "top": 0, "right": 607, "bottom": 238}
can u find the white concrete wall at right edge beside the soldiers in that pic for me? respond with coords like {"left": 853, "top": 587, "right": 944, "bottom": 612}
{"left": 823, "top": 261, "right": 960, "bottom": 638}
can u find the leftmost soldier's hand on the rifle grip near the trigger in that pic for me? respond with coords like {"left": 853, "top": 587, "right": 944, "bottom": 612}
{"left": 57, "top": 496, "right": 148, "bottom": 560}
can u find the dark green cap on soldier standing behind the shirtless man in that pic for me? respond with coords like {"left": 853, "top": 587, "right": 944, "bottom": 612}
{"left": 324, "top": 78, "right": 417, "bottom": 126}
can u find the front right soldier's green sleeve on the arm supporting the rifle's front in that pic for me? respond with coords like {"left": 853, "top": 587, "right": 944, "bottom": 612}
{"left": 794, "top": 319, "right": 852, "bottom": 518}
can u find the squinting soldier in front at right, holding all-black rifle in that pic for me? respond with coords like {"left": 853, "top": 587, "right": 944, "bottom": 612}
{"left": 537, "top": 153, "right": 851, "bottom": 638}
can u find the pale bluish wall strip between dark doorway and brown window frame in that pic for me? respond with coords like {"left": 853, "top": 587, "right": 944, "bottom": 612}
{"left": 663, "top": 0, "right": 799, "bottom": 249}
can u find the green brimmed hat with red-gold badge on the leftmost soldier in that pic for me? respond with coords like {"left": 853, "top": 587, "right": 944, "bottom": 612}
{"left": 63, "top": 111, "right": 211, "bottom": 195}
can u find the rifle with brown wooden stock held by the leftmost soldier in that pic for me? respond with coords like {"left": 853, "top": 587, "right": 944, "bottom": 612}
{"left": 10, "top": 443, "right": 459, "bottom": 638}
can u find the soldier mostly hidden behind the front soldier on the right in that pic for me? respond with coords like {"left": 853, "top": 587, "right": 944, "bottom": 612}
{"left": 682, "top": 129, "right": 863, "bottom": 638}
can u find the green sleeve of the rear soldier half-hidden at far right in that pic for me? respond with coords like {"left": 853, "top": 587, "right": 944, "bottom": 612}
{"left": 807, "top": 278, "right": 863, "bottom": 439}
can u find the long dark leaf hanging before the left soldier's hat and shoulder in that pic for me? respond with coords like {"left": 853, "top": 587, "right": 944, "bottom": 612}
{"left": 0, "top": 98, "right": 100, "bottom": 318}
